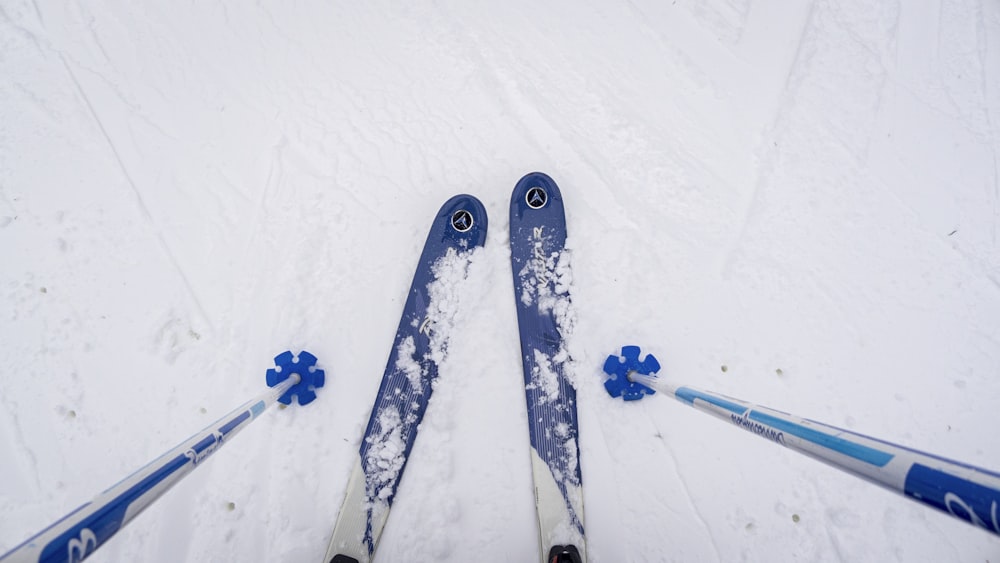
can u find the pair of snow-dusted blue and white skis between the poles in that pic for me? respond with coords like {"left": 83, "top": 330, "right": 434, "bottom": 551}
{"left": 323, "top": 172, "right": 586, "bottom": 563}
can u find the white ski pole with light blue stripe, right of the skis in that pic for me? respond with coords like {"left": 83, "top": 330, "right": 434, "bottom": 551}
{"left": 604, "top": 346, "right": 1000, "bottom": 535}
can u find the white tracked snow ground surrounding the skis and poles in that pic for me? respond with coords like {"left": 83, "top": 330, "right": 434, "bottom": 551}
{"left": 0, "top": 0, "right": 1000, "bottom": 563}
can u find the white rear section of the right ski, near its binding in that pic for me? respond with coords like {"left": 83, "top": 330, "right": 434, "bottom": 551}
{"left": 531, "top": 448, "right": 587, "bottom": 563}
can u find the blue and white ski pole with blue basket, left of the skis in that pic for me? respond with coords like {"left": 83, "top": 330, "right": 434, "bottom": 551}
{"left": 0, "top": 351, "right": 324, "bottom": 563}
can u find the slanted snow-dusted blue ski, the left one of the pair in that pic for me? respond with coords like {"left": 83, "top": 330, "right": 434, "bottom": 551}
{"left": 323, "top": 195, "right": 487, "bottom": 563}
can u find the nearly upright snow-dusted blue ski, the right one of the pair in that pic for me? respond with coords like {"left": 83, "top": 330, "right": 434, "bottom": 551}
{"left": 510, "top": 172, "right": 587, "bottom": 563}
